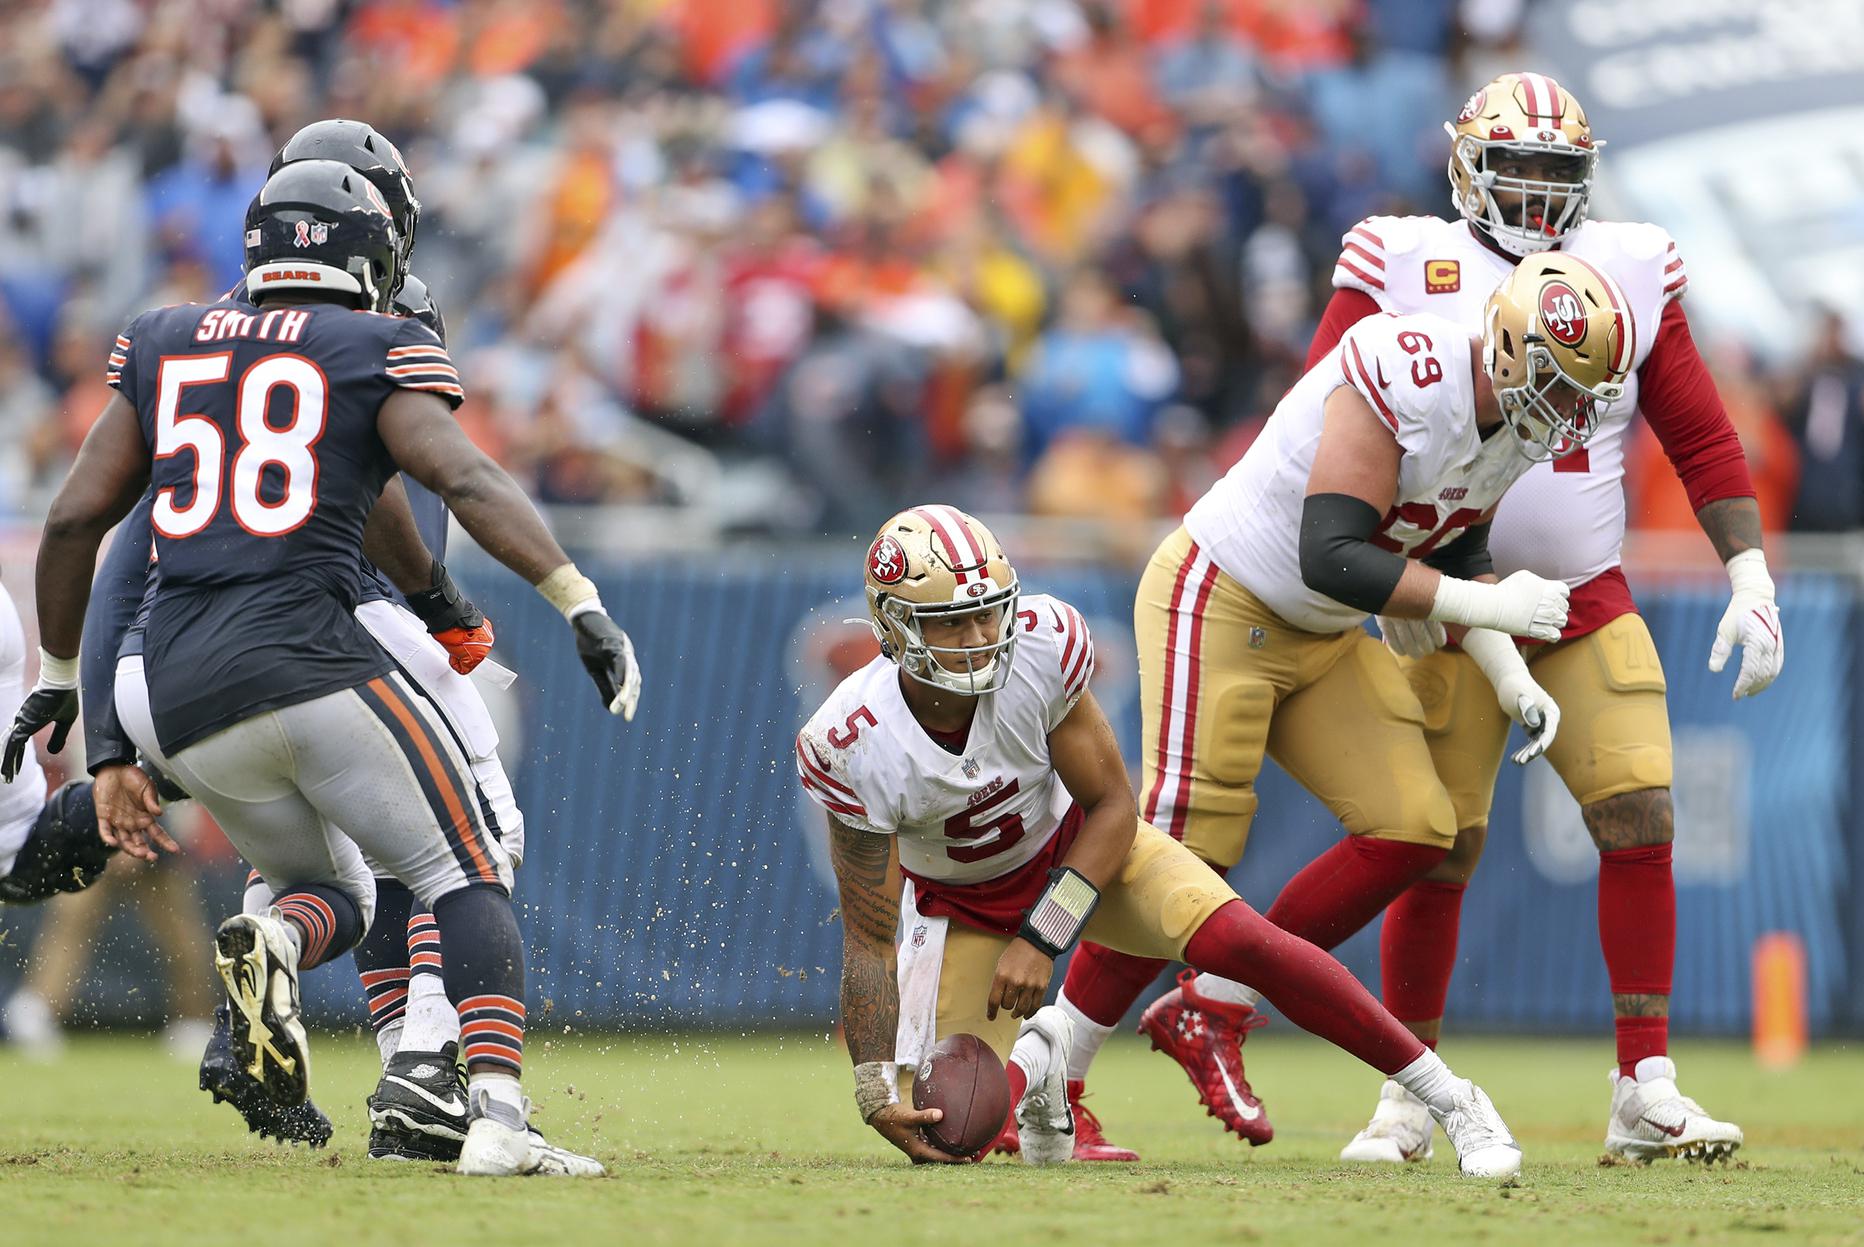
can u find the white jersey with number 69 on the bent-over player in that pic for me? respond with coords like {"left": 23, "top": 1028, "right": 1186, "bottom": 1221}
{"left": 1184, "top": 315, "right": 1528, "bottom": 632}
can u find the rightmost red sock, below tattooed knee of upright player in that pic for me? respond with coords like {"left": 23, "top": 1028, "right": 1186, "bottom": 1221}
{"left": 1599, "top": 844, "right": 1676, "bottom": 1076}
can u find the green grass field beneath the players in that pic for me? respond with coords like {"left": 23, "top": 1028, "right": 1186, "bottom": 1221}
{"left": 0, "top": 1027, "right": 1864, "bottom": 1247}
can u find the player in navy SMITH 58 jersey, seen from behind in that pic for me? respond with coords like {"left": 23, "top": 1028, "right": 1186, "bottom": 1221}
{"left": 16, "top": 160, "right": 639, "bottom": 1174}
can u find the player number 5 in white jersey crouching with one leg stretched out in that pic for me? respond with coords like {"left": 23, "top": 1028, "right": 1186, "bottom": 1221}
{"left": 796, "top": 505, "right": 1521, "bottom": 1176}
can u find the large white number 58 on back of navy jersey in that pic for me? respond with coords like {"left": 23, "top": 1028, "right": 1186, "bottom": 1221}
{"left": 151, "top": 350, "right": 330, "bottom": 541}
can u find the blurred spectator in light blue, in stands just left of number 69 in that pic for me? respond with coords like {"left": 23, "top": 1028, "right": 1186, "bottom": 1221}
{"left": 1016, "top": 268, "right": 1178, "bottom": 457}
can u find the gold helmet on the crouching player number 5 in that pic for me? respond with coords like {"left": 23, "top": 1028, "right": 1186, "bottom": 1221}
{"left": 867, "top": 503, "right": 1021, "bottom": 695}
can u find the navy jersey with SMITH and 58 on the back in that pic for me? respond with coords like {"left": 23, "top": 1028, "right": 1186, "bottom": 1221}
{"left": 106, "top": 300, "right": 464, "bottom": 751}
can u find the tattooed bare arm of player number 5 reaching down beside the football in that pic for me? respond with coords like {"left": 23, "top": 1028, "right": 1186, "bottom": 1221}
{"left": 828, "top": 815, "right": 962, "bottom": 1163}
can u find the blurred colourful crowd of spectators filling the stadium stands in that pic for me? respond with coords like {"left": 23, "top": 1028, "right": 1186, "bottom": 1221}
{"left": 0, "top": 0, "right": 1864, "bottom": 536}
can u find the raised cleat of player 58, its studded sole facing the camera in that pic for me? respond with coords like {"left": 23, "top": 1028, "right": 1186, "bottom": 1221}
{"left": 214, "top": 908, "right": 311, "bottom": 1107}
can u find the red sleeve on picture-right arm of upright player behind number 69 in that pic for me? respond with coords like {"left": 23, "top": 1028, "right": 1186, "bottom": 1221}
{"left": 1638, "top": 298, "right": 1754, "bottom": 511}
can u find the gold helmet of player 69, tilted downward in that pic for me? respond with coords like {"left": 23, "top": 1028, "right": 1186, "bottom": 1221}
{"left": 1482, "top": 252, "right": 1637, "bottom": 462}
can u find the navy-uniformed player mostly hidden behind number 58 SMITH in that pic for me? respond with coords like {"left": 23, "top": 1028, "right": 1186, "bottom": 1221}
{"left": 34, "top": 119, "right": 524, "bottom": 1159}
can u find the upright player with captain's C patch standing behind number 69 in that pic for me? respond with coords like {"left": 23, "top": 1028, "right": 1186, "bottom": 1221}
{"left": 1309, "top": 73, "right": 1752, "bottom": 1161}
